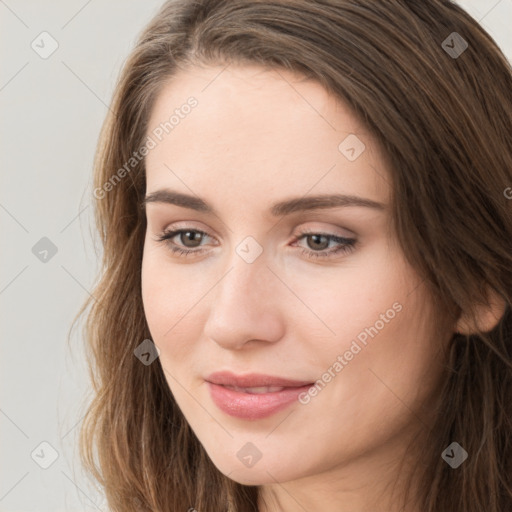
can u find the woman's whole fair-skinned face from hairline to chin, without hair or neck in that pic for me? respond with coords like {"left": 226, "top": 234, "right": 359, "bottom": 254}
{"left": 142, "top": 66, "right": 452, "bottom": 484}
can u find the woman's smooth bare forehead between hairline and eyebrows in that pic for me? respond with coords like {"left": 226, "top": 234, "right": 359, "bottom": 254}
{"left": 142, "top": 65, "right": 390, "bottom": 210}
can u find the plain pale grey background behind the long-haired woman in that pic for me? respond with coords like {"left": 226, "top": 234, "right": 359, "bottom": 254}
{"left": 0, "top": 0, "right": 512, "bottom": 512}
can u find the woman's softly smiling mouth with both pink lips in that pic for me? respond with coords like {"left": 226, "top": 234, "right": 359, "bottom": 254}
{"left": 205, "top": 372, "right": 314, "bottom": 420}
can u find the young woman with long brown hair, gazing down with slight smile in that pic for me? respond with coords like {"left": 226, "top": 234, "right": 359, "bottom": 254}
{"left": 75, "top": 0, "right": 512, "bottom": 512}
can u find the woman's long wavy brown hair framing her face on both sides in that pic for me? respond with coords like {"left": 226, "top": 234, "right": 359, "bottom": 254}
{"left": 75, "top": 0, "right": 512, "bottom": 512}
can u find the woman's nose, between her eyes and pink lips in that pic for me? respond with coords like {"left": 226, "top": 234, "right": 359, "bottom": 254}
{"left": 204, "top": 256, "right": 284, "bottom": 350}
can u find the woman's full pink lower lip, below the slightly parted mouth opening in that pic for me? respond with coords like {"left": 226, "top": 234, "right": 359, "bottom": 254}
{"left": 207, "top": 382, "right": 313, "bottom": 420}
